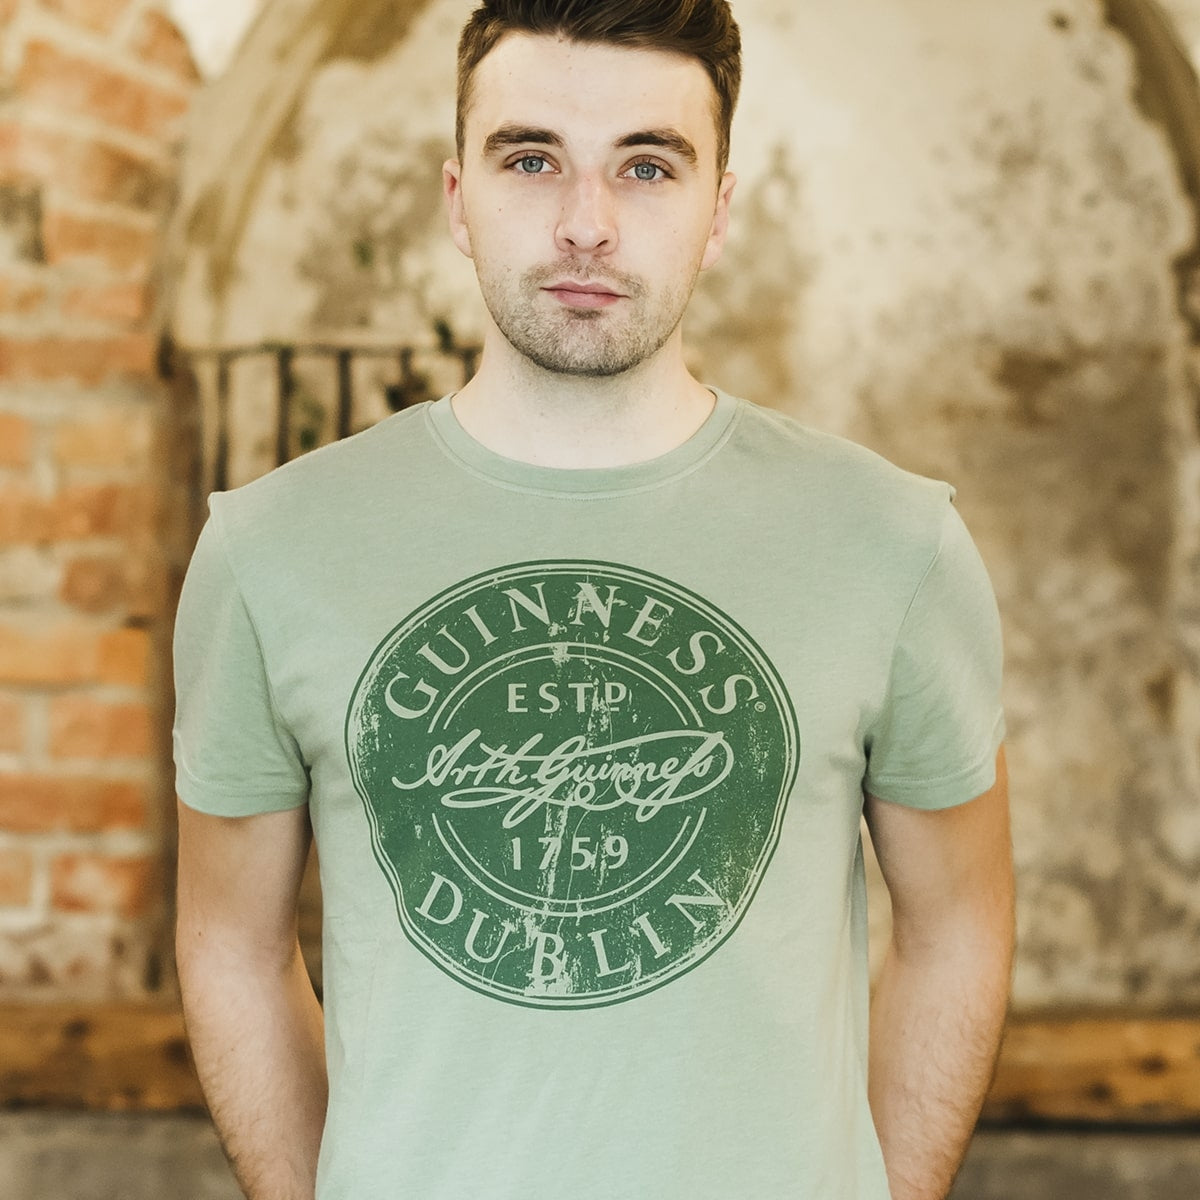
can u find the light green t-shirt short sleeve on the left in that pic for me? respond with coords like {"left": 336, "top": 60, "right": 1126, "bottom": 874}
{"left": 172, "top": 518, "right": 308, "bottom": 816}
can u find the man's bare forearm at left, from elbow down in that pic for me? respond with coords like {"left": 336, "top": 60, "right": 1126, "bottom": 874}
{"left": 179, "top": 947, "right": 328, "bottom": 1200}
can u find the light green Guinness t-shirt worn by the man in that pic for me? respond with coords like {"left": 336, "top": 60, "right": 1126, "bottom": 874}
{"left": 175, "top": 394, "right": 1003, "bottom": 1200}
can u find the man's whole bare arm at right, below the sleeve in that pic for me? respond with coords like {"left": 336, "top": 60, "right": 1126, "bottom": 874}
{"left": 865, "top": 749, "right": 1014, "bottom": 1200}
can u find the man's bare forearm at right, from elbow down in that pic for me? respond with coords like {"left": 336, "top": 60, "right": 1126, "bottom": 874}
{"left": 870, "top": 930, "right": 1012, "bottom": 1200}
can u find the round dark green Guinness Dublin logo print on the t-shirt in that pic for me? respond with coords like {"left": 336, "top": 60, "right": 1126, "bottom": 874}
{"left": 346, "top": 562, "right": 799, "bottom": 1008}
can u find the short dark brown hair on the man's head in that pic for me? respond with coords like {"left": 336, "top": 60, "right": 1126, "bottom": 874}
{"left": 455, "top": 0, "right": 742, "bottom": 173}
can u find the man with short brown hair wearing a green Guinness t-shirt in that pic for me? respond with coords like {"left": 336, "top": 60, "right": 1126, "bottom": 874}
{"left": 176, "top": 0, "right": 1013, "bottom": 1200}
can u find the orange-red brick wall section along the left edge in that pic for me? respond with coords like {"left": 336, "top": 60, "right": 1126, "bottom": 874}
{"left": 0, "top": 0, "right": 198, "bottom": 1001}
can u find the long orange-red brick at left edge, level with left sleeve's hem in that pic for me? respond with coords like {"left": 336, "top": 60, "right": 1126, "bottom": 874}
{"left": 0, "top": 772, "right": 148, "bottom": 833}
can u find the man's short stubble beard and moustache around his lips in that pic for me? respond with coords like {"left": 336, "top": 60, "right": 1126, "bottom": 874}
{"left": 480, "top": 264, "right": 698, "bottom": 379}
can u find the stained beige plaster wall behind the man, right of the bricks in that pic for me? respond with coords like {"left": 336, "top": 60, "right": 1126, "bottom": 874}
{"left": 166, "top": 0, "right": 1200, "bottom": 1009}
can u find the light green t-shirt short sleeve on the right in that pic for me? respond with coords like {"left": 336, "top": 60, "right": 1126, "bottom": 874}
{"left": 865, "top": 503, "right": 1004, "bottom": 809}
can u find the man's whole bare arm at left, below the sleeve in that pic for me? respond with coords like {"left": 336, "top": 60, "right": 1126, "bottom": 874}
{"left": 175, "top": 804, "right": 328, "bottom": 1200}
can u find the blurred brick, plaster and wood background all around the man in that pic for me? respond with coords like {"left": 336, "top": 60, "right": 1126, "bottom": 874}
{"left": 0, "top": 0, "right": 1200, "bottom": 1200}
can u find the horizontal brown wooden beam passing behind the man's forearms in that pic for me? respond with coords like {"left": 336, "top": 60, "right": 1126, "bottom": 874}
{"left": 0, "top": 1006, "right": 1200, "bottom": 1126}
